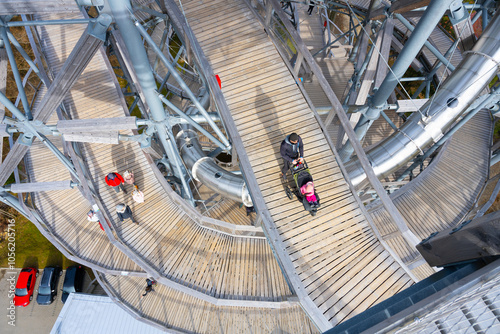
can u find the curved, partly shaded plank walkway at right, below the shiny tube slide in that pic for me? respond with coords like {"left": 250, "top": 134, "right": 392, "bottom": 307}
{"left": 369, "top": 111, "right": 492, "bottom": 279}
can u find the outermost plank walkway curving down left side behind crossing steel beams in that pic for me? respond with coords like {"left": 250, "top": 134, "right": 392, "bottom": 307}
{"left": 26, "top": 14, "right": 142, "bottom": 273}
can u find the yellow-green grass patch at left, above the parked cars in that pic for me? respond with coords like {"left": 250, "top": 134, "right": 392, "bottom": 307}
{"left": 0, "top": 214, "right": 75, "bottom": 269}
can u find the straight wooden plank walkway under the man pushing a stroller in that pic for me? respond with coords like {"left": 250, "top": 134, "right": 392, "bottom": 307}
{"left": 182, "top": 0, "right": 412, "bottom": 326}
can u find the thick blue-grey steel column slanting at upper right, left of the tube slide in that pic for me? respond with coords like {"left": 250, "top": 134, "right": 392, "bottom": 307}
{"left": 339, "top": 0, "right": 454, "bottom": 161}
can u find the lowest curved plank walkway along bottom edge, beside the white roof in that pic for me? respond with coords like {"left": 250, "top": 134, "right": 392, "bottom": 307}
{"left": 97, "top": 273, "right": 319, "bottom": 334}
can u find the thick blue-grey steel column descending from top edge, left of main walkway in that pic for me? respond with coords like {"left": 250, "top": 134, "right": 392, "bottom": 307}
{"left": 108, "top": 0, "right": 194, "bottom": 205}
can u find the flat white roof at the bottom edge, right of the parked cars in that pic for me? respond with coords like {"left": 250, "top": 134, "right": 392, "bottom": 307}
{"left": 50, "top": 293, "right": 165, "bottom": 334}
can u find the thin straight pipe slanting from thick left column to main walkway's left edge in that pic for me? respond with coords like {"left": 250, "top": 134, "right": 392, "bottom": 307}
{"left": 133, "top": 19, "right": 231, "bottom": 151}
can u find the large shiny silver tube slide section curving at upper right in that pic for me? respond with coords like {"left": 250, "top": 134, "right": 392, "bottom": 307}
{"left": 346, "top": 13, "right": 500, "bottom": 186}
